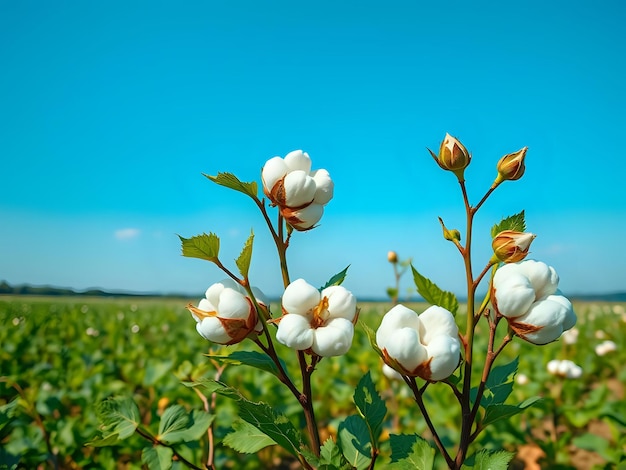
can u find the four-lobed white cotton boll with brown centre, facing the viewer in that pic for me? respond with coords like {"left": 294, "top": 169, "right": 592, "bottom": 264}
{"left": 276, "top": 279, "right": 357, "bottom": 356}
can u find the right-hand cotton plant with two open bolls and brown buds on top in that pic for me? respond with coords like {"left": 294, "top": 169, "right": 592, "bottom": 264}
{"left": 369, "top": 134, "right": 576, "bottom": 469}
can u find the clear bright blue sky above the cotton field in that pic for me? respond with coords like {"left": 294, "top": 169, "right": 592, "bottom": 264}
{"left": 0, "top": 1, "right": 626, "bottom": 297}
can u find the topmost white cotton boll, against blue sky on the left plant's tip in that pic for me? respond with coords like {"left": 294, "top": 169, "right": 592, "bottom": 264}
{"left": 261, "top": 150, "right": 334, "bottom": 231}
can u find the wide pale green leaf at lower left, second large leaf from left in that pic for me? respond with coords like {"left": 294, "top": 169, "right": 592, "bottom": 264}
{"left": 157, "top": 405, "right": 214, "bottom": 444}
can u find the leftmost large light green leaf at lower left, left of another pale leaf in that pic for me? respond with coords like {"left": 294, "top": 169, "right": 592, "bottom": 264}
{"left": 96, "top": 397, "right": 141, "bottom": 442}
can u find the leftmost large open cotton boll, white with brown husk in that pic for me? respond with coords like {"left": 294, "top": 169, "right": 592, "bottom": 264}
{"left": 187, "top": 279, "right": 267, "bottom": 345}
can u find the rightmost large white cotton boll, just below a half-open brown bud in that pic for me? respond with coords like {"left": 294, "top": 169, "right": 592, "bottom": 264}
{"left": 491, "top": 260, "right": 576, "bottom": 344}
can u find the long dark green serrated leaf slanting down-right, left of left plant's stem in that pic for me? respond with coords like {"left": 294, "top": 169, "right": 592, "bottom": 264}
{"left": 238, "top": 397, "right": 304, "bottom": 457}
